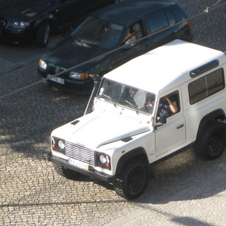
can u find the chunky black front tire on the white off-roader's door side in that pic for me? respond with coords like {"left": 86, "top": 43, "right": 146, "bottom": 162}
{"left": 114, "top": 159, "right": 148, "bottom": 200}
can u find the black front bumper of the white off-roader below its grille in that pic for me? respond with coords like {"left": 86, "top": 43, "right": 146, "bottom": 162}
{"left": 48, "top": 153, "right": 115, "bottom": 183}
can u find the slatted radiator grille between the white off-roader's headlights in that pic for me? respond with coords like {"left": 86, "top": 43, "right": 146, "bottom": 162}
{"left": 65, "top": 141, "right": 95, "bottom": 166}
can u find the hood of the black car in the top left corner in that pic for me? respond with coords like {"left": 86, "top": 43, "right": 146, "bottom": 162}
{"left": 0, "top": 0, "right": 49, "bottom": 20}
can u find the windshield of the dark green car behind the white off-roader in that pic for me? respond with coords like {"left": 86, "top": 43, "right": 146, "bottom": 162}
{"left": 71, "top": 16, "right": 123, "bottom": 49}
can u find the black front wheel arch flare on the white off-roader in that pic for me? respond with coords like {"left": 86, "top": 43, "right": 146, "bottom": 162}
{"left": 115, "top": 147, "right": 148, "bottom": 175}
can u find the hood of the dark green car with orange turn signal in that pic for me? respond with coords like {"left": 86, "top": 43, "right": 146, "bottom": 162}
{"left": 42, "top": 40, "right": 109, "bottom": 72}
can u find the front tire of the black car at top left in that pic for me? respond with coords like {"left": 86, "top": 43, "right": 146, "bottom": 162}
{"left": 34, "top": 21, "right": 50, "bottom": 48}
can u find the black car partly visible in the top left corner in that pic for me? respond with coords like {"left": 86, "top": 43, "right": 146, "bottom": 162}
{"left": 0, "top": 0, "right": 116, "bottom": 47}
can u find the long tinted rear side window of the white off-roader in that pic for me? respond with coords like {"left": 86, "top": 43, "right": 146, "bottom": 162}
{"left": 188, "top": 68, "right": 225, "bottom": 104}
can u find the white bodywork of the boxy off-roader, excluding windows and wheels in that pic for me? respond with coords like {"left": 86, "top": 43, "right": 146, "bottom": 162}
{"left": 51, "top": 40, "right": 226, "bottom": 178}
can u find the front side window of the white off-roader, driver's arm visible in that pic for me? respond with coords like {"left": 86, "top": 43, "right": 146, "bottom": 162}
{"left": 157, "top": 91, "right": 180, "bottom": 117}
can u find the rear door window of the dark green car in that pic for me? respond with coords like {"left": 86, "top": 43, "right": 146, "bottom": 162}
{"left": 145, "top": 11, "right": 169, "bottom": 33}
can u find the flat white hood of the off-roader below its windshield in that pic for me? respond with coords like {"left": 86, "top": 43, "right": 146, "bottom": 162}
{"left": 53, "top": 112, "right": 150, "bottom": 149}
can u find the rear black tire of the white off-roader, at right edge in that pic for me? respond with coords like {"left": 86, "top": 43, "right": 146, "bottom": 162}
{"left": 194, "top": 121, "right": 226, "bottom": 160}
